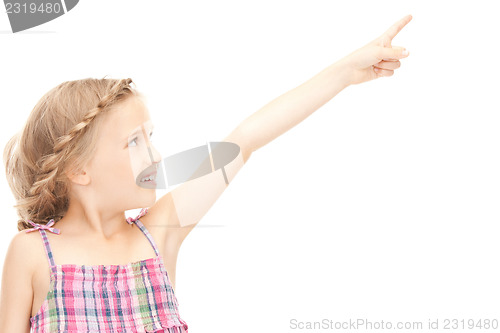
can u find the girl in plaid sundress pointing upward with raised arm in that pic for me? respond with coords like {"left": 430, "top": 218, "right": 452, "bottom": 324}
{"left": 0, "top": 15, "right": 412, "bottom": 333}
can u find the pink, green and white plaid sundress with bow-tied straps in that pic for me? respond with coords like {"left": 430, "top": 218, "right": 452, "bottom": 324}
{"left": 26, "top": 209, "right": 188, "bottom": 333}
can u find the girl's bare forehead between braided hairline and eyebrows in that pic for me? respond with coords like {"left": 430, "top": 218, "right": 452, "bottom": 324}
{"left": 102, "top": 97, "right": 151, "bottom": 138}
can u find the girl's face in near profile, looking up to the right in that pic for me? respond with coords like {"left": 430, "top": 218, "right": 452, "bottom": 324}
{"left": 88, "top": 97, "right": 161, "bottom": 210}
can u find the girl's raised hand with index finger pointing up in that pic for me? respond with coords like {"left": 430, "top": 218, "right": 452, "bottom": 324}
{"left": 340, "top": 15, "right": 412, "bottom": 84}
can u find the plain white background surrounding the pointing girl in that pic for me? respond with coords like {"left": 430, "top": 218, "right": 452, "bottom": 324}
{"left": 0, "top": 0, "right": 500, "bottom": 333}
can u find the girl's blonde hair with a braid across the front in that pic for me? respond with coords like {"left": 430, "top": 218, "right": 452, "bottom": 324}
{"left": 3, "top": 78, "right": 143, "bottom": 231}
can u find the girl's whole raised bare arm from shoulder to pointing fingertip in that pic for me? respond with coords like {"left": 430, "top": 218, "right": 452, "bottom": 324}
{"left": 150, "top": 15, "right": 412, "bottom": 246}
